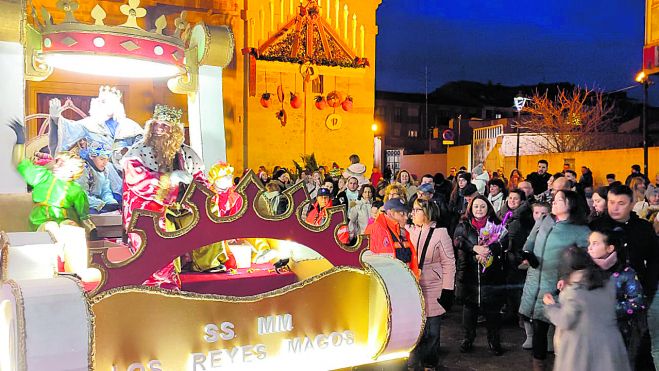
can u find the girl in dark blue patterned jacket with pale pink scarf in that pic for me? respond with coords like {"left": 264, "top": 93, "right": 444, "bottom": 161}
{"left": 588, "top": 231, "right": 645, "bottom": 369}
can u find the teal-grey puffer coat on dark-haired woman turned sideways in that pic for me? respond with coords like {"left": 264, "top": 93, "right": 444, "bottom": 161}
{"left": 519, "top": 215, "right": 590, "bottom": 322}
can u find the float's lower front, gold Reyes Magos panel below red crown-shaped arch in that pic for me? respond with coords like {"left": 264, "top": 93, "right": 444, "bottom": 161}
{"left": 0, "top": 173, "right": 425, "bottom": 370}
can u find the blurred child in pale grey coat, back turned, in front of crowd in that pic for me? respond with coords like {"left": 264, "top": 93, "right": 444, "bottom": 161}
{"left": 543, "top": 247, "right": 630, "bottom": 371}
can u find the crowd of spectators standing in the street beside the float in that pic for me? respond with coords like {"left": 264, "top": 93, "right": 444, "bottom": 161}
{"left": 258, "top": 155, "right": 659, "bottom": 370}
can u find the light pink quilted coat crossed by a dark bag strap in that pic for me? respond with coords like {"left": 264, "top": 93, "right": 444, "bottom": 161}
{"left": 406, "top": 222, "right": 455, "bottom": 317}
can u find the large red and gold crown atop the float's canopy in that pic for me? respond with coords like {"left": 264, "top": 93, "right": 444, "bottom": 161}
{"left": 32, "top": 0, "right": 187, "bottom": 71}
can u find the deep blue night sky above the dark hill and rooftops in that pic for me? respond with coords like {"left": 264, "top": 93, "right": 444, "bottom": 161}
{"left": 376, "top": 0, "right": 648, "bottom": 100}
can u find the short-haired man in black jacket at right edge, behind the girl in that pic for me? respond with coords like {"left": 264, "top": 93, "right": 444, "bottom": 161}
{"left": 590, "top": 185, "right": 659, "bottom": 369}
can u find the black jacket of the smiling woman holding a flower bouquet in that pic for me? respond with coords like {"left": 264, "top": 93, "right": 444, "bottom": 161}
{"left": 453, "top": 220, "right": 506, "bottom": 307}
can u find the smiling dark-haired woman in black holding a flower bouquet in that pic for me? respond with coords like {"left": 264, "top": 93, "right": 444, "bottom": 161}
{"left": 453, "top": 195, "right": 506, "bottom": 356}
